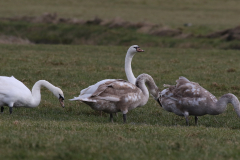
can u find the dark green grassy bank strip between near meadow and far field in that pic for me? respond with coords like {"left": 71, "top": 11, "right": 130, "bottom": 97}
{"left": 0, "top": 21, "right": 240, "bottom": 49}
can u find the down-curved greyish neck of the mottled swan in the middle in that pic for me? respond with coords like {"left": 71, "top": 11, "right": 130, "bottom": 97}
{"left": 136, "top": 74, "right": 158, "bottom": 98}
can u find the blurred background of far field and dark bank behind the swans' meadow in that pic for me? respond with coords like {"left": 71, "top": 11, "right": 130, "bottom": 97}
{"left": 0, "top": 0, "right": 240, "bottom": 49}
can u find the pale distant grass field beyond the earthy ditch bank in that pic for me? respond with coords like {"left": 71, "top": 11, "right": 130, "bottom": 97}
{"left": 0, "top": 0, "right": 240, "bottom": 30}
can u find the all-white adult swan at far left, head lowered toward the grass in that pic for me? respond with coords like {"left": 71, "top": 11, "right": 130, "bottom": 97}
{"left": 0, "top": 76, "right": 64, "bottom": 114}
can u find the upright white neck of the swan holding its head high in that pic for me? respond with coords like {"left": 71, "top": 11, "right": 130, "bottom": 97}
{"left": 125, "top": 51, "right": 136, "bottom": 84}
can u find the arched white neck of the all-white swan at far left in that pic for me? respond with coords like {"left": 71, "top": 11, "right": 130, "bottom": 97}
{"left": 30, "top": 80, "right": 56, "bottom": 107}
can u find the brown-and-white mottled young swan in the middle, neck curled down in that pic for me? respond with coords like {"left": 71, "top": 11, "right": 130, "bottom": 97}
{"left": 70, "top": 74, "right": 160, "bottom": 122}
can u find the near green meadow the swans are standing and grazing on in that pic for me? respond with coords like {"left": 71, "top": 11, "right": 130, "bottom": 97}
{"left": 0, "top": 43, "right": 240, "bottom": 160}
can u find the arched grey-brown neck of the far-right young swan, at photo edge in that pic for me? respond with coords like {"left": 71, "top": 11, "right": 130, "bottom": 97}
{"left": 212, "top": 93, "right": 240, "bottom": 118}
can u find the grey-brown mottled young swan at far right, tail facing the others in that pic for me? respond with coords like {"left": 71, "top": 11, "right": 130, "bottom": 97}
{"left": 159, "top": 77, "right": 240, "bottom": 125}
